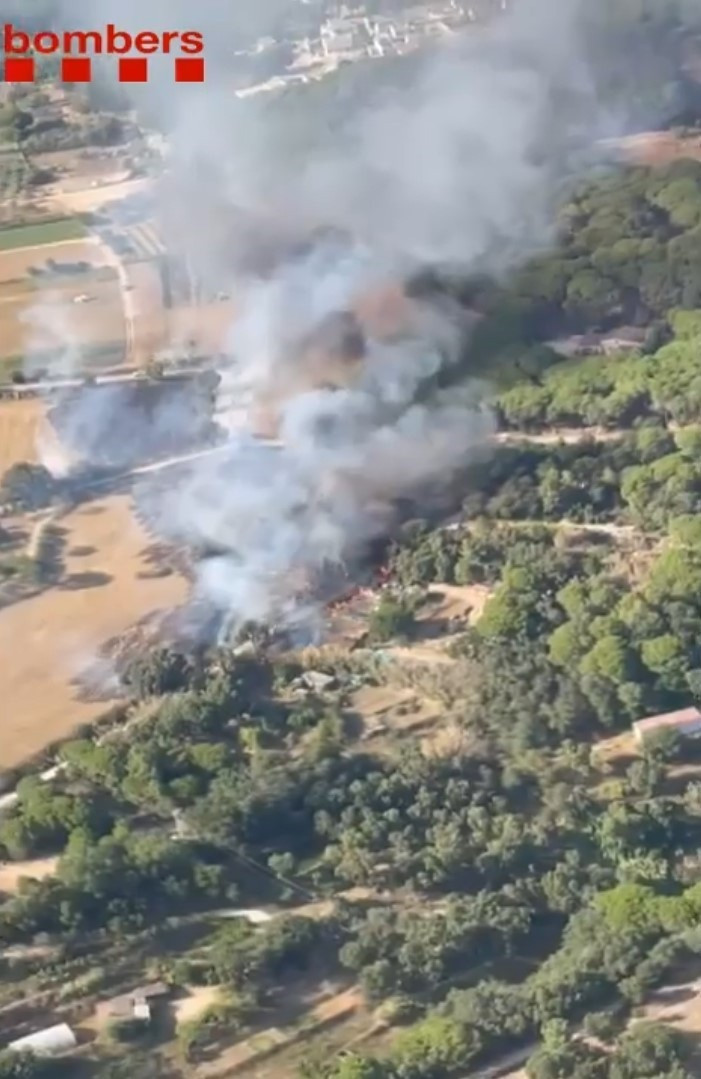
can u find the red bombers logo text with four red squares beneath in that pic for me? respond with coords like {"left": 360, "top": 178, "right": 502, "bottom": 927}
{"left": 2, "top": 23, "right": 205, "bottom": 82}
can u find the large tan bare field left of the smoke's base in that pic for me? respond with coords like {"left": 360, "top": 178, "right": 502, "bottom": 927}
{"left": 0, "top": 495, "right": 187, "bottom": 769}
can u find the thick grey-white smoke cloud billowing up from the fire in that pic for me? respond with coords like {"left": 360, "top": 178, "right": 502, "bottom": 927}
{"left": 31, "top": 0, "right": 612, "bottom": 627}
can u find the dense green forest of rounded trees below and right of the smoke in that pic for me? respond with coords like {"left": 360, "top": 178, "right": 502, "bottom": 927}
{"left": 6, "top": 312, "right": 701, "bottom": 1079}
